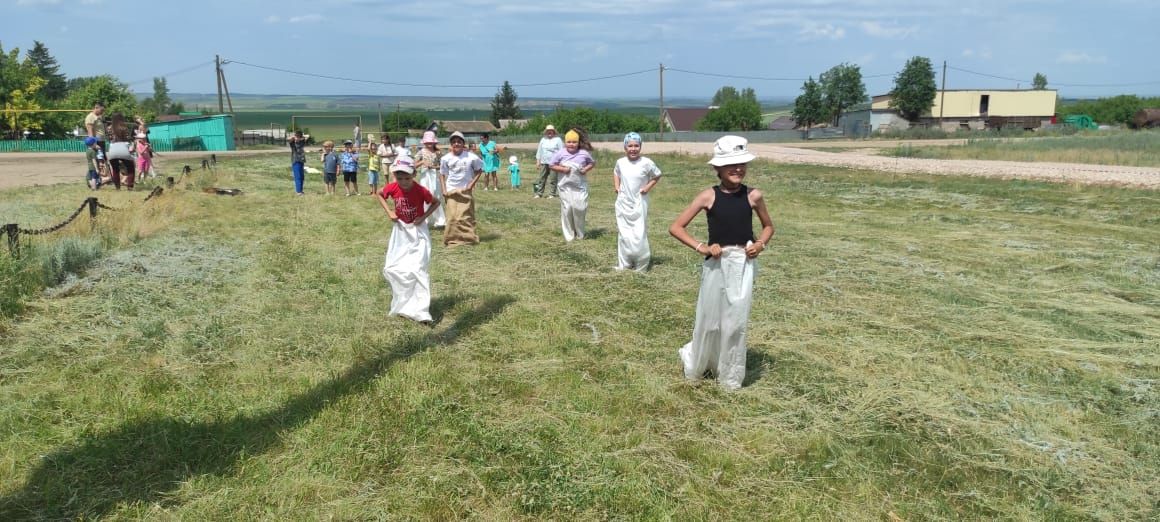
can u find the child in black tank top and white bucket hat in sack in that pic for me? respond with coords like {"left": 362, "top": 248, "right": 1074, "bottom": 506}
{"left": 668, "top": 136, "right": 774, "bottom": 390}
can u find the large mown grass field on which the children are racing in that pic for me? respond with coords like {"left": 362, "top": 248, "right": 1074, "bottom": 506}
{"left": 0, "top": 153, "right": 1160, "bottom": 521}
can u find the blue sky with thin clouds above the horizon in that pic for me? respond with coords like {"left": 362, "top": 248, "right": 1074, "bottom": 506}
{"left": 0, "top": 0, "right": 1160, "bottom": 97}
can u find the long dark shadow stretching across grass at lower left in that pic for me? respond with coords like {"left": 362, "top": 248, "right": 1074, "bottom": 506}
{"left": 0, "top": 296, "right": 515, "bottom": 520}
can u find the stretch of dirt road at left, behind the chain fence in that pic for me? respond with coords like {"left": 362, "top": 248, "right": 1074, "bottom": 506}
{"left": 0, "top": 150, "right": 278, "bottom": 190}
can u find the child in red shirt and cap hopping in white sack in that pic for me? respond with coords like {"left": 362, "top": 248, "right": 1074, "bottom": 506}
{"left": 378, "top": 158, "right": 438, "bottom": 325}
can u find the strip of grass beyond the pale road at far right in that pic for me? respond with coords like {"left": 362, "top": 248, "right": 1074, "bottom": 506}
{"left": 885, "top": 130, "right": 1160, "bottom": 167}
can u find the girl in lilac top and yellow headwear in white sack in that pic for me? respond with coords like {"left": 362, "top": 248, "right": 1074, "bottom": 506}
{"left": 549, "top": 129, "right": 596, "bottom": 242}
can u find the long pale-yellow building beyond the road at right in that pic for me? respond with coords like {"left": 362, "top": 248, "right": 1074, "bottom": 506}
{"left": 870, "top": 89, "right": 1056, "bottom": 130}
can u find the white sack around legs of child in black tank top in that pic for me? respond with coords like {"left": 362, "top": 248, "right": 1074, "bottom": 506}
{"left": 677, "top": 247, "right": 757, "bottom": 390}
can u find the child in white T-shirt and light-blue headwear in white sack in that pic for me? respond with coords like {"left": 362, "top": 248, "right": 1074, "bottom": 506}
{"left": 612, "top": 132, "right": 660, "bottom": 271}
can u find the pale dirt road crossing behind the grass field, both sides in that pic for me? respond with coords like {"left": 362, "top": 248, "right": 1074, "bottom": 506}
{"left": 0, "top": 139, "right": 1160, "bottom": 189}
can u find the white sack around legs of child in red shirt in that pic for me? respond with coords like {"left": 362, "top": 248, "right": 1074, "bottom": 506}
{"left": 383, "top": 220, "right": 432, "bottom": 321}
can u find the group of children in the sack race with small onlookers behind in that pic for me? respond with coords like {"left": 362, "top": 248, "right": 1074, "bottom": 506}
{"left": 303, "top": 129, "right": 774, "bottom": 390}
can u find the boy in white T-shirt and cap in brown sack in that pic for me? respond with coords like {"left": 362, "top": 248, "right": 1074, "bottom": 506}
{"left": 438, "top": 131, "right": 484, "bottom": 246}
